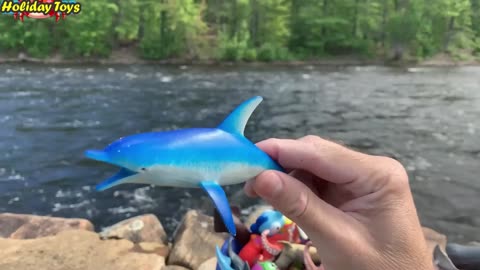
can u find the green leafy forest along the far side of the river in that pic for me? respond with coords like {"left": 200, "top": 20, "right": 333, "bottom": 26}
{"left": 0, "top": 0, "right": 480, "bottom": 61}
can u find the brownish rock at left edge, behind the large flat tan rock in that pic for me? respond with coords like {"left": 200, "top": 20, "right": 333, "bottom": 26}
{"left": 0, "top": 213, "right": 94, "bottom": 239}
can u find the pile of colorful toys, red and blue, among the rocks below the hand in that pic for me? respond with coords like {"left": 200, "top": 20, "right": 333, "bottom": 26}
{"left": 215, "top": 210, "right": 319, "bottom": 270}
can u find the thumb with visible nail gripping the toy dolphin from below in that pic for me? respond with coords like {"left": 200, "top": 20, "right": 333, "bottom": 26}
{"left": 250, "top": 171, "right": 351, "bottom": 243}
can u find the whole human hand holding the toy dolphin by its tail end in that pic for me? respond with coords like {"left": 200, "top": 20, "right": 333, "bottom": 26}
{"left": 245, "top": 136, "right": 434, "bottom": 270}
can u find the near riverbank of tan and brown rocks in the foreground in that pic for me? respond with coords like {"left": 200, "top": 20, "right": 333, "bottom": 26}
{"left": 0, "top": 211, "right": 478, "bottom": 270}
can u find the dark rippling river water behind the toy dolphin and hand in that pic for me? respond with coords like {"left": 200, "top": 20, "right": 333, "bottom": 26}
{"left": 0, "top": 65, "right": 480, "bottom": 242}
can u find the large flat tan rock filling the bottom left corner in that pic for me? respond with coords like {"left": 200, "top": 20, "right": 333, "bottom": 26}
{"left": 0, "top": 230, "right": 165, "bottom": 270}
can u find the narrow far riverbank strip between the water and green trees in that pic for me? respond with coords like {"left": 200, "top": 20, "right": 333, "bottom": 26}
{"left": 0, "top": 48, "right": 480, "bottom": 67}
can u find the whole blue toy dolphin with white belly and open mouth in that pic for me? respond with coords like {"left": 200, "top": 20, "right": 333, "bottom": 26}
{"left": 85, "top": 96, "right": 283, "bottom": 235}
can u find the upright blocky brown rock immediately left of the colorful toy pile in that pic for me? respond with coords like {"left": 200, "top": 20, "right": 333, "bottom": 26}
{"left": 168, "top": 210, "right": 228, "bottom": 270}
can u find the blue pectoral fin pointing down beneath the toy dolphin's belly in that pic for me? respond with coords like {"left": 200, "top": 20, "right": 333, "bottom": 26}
{"left": 200, "top": 181, "right": 237, "bottom": 236}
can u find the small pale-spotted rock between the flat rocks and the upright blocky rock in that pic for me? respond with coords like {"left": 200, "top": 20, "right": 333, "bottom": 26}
{"left": 100, "top": 214, "right": 167, "bottom": 244}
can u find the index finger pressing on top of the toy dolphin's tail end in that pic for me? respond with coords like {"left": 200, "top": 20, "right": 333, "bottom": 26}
{"left": 257, "top": 136, "right": 375, "bottom": 184}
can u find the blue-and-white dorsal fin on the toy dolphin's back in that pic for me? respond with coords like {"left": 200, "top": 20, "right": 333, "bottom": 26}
{"left": 218, "top": 96, "right": 263, "bottom": 136}
